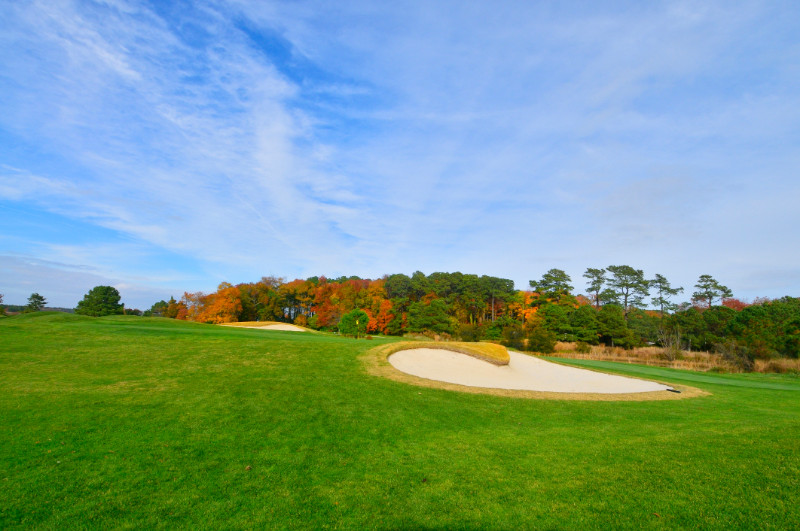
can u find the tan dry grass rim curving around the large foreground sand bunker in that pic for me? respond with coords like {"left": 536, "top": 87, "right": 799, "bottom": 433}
{"left": 360, "top": 341, "right": 709, "bottom": 402}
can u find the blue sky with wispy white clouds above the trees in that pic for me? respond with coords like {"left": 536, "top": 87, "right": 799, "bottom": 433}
{"left": 0, "top": 0, "right": 800, "bottom": 308}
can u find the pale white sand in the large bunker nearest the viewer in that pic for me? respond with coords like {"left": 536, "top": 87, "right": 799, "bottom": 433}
{"left": 389, "top": 348, "right": 670, "bottom": 394}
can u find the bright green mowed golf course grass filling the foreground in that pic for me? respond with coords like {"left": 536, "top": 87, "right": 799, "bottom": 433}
{"left": 0, "top": 313, "right": 800, "bottom": 529}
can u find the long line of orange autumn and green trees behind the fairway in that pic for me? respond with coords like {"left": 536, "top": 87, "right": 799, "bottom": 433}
{"left": 138, "top": 265, "right": 800, "bottom": 358}
